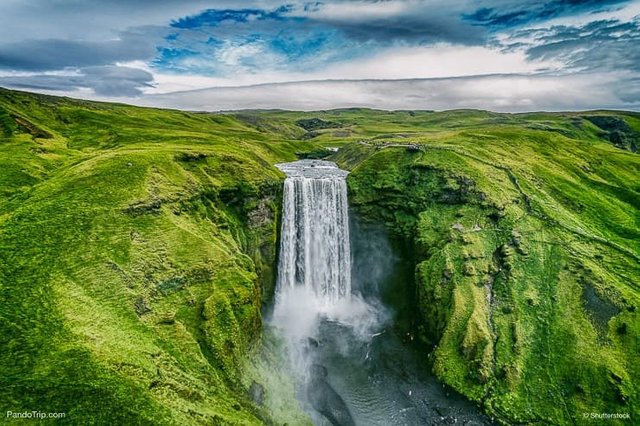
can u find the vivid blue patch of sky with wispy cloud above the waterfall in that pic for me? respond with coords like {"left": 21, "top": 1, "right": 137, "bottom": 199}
{"left": 153, "top": 7, "right": 362, "bottom": 76}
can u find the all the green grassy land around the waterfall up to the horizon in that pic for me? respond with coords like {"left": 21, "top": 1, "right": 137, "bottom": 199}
{"left": 0, "top": 89, "right": 640, "bottom": 424}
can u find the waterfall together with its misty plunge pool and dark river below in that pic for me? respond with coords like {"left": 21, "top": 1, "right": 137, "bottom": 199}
{"left": 270, "top": 160, "right": 490, "bottom": 426}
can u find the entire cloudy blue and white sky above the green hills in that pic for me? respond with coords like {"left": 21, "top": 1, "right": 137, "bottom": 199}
{"left": 0, "top": 0, "right": 640, "bottom": 112}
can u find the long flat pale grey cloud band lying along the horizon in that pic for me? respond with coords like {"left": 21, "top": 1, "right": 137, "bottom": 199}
{"left": 138, "top": 74, "right": 640, "bottom": 111}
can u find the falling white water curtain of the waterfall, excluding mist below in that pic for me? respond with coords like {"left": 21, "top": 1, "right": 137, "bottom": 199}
{"left": 276, "top": 160, "right": 351, "bottom": 304}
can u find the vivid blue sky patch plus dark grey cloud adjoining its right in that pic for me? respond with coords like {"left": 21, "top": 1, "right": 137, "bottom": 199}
{"left": 153, "top": 0, "right": 486, "bottom": 76}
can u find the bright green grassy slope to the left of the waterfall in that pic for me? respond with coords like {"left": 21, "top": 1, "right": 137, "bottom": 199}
{"left": 0, "top": 90, "right": 312, "bottom": 424}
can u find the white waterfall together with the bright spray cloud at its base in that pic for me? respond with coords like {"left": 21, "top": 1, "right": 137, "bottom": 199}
{"left": 272, "top": 160, "right": 380, "bottom": 381}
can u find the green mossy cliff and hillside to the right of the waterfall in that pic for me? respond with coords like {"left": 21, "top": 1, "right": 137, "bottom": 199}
{"left": 337, "top": 129, "right": 640, "bottom": 424}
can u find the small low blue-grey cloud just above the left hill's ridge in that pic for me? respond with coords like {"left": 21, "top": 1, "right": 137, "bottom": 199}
{"left": 0, "top": 66, "right": 153, "bottom": 97}
